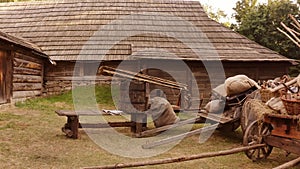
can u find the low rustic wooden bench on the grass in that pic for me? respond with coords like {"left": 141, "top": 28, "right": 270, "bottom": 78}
{"left": 55, "top": 110, "right": 147, "bottom": 139}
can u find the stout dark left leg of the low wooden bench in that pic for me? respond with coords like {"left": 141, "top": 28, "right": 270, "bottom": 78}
{"left": 62, "top": 116, "right": 79, "bottom": 139}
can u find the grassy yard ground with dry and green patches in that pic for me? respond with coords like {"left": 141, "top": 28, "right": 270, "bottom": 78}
{"left": 0, "top": 86, "right": 296, "bottom": 169}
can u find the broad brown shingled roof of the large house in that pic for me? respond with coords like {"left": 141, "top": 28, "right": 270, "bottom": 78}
{"left": 0, "top": 0, "right": 288, "bottom": 61}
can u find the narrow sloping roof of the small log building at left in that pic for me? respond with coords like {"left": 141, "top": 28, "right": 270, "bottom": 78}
{"left": 0, "top": 29, "right": 48, "bottom": 58}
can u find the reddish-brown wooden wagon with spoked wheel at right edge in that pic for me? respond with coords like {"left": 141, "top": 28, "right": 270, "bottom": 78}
{"left": 243, "top": 98, "right": 300, "bottom": 169}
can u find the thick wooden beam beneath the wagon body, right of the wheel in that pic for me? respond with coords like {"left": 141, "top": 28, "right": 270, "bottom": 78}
{"left": 264, "top": 135, "right": 300, "bottom": 155}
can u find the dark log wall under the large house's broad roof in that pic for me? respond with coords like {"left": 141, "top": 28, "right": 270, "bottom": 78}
{"left": 45, "top": 60, "right": 290, "bottom": 106}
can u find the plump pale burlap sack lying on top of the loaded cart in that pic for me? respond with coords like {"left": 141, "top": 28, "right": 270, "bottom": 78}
{"left": 225, "top": 75, "right": 260, "bottom": 96}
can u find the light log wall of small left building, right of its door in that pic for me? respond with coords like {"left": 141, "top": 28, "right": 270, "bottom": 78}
{"left": 12, "top": 51, "right": 45, "bottom": 101}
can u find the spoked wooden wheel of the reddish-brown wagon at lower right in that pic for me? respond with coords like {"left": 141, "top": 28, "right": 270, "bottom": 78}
{"left": 243, "top": 120, "right": 273, "bottom": 161}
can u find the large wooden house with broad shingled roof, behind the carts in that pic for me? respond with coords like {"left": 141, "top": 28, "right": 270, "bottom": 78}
{"left": 0, "top": 0, "right": 291, "bottom": 105}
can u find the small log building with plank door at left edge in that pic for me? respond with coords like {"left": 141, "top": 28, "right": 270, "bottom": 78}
{"left": 0, "top": 32, "right": 49, "bottom": 105}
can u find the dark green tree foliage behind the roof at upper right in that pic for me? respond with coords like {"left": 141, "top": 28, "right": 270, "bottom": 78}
{"left": 234, "top": 0, "right": 300, "bottom": 59}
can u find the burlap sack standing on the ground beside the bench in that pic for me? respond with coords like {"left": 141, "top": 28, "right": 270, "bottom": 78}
{"left": 147, "top": 97, "right": 180, "bottom": 127}
